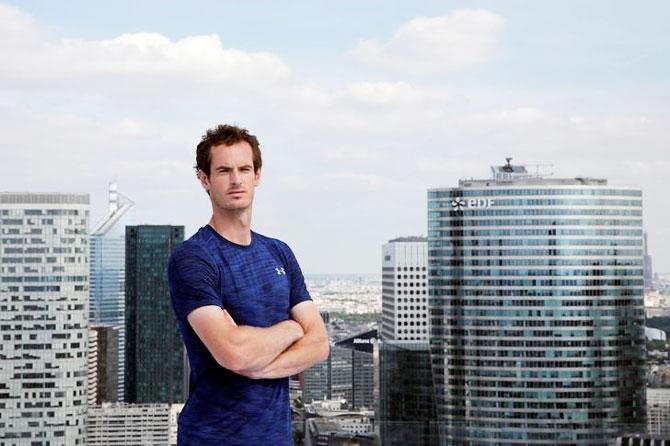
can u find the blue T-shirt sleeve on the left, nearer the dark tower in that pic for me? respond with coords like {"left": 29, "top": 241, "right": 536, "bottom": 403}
{"left": 168, "top": 243, "right": 224, "bottom": 323}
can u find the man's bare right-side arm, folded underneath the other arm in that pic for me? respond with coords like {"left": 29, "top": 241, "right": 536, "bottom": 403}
{"left": 242, "top": 301, "right": 330, "bottom": 379}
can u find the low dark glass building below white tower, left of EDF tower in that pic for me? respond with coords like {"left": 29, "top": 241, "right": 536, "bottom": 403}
{"left": 377, "top": 341, "right": 438, "bottom": 446}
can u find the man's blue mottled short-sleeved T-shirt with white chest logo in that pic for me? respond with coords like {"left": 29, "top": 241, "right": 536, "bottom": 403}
{"left": 168, "top": 225, "right": 311, "bottom": 446}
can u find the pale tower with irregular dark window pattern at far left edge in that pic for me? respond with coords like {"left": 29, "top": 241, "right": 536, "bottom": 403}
{"left": 0, "top": 193, "right": 89, "bottom": 446}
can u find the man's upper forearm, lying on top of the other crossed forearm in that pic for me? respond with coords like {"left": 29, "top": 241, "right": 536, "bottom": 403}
{"left": 231, "top": 319, "right": 304, "bottom": 375}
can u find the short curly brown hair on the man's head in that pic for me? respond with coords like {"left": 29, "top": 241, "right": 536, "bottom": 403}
{"left": 195, "top": 124, "right": 263, "bottom": 176}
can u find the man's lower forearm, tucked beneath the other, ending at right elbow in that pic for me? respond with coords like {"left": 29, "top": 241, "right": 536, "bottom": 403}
{"left": 243, "top": 332, "right": 329, "bottom": 379}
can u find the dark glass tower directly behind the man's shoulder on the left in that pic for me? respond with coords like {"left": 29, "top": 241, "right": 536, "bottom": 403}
{"left": 125, "top": 225, "right": 187, "bottom": 403}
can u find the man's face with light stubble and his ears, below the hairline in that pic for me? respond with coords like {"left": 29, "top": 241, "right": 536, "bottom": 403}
{"left": 200, "top": 141, "right": 261, "bottom": 211}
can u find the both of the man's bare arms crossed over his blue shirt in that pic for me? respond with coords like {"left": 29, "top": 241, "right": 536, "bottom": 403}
{"left": 187, "top": 301, "right": 329, "bottom": 379}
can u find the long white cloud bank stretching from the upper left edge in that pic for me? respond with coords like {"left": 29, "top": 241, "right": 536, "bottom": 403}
{"left": 0, "top": 5, "right": 290, "bottom": 86}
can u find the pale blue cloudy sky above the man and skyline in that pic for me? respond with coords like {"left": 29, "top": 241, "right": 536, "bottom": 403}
{"left": 0, "top": 0, "right": 670, "bottom": 274}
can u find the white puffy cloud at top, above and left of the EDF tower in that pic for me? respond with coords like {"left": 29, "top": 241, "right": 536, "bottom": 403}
{"left": 352, "top": 9, "right": 504, "bottom": 74}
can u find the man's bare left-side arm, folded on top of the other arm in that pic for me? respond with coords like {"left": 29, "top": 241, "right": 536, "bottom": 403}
{"left": 187, "top": 305, "right": 305, "bottom": 376}
